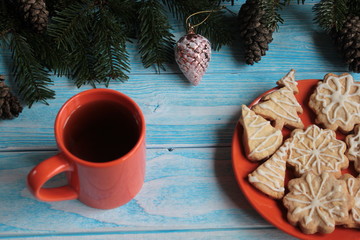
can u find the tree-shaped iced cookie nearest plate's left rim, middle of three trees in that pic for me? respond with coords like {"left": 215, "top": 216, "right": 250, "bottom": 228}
{"left": 239, "top": 105, "right": 283, "bottom": 161}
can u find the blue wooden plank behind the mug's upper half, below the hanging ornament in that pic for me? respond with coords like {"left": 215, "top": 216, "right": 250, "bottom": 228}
{"left": 0, "top": 69, "right": 360, "bottom": 151}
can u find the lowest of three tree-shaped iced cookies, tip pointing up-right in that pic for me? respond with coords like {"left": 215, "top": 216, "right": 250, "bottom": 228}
{"left": 248, "top": 141, "right": 289, "bottom": 199}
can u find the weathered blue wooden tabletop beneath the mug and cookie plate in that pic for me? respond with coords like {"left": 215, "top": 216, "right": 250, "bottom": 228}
{"left": 0, "top": 1, "right": 360, "bottom": 239}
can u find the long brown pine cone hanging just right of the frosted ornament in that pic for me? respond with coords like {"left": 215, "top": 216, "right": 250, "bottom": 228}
{"left": 238, "top": 0, "right": 275, "bottom": 65}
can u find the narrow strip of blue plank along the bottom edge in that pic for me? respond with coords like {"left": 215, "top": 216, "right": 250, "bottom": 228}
{"left": 0, "top": 229, "right": 295, "bottom": 240}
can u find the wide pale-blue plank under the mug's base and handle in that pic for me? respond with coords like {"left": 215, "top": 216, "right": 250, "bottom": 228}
{"left": 0, "top": 148, "right": 282, "bottom": 237}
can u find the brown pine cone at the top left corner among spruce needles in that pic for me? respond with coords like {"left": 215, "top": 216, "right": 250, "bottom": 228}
{"left": 20, "top": 0, "right": 49, "bottom": 32}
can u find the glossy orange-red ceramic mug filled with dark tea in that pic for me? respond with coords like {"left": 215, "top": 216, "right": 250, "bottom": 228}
{"left": 27, "top": 89, "right": 146, "bottom": 209}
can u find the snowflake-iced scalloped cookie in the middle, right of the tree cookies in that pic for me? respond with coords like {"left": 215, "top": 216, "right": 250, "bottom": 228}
{"left": 287, "top": 125, "right": 349, "bottom": 177}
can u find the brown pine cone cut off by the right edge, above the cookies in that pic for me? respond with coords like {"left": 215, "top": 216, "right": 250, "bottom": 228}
{"left": 331, "top": 16, "right": 360, "bottom": 73}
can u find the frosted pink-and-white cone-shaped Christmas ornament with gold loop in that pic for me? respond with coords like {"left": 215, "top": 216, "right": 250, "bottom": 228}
{"left": 175, "top": 29, "right": 211, "bottom": 86}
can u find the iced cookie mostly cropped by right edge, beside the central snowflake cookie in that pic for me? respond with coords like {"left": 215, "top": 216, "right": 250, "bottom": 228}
{"left": 345, "top": 125, "right": 360, "bottom": 172}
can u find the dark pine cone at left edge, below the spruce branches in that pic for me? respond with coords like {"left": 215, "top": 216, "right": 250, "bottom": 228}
{"left": 0, "top": 76, "right": 22, "bottom": 119}
